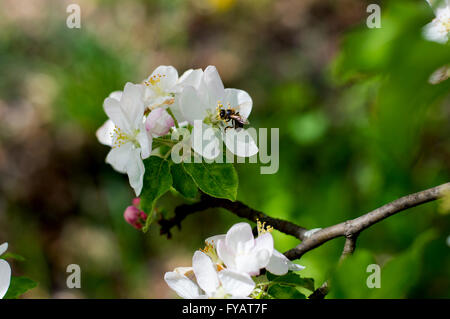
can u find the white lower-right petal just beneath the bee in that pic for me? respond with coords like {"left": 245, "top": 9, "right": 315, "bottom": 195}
{"left": 224, "top": 129, "right": 258, "bottom": 157}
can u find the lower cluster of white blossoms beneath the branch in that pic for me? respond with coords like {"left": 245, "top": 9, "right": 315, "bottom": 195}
{"left": 164, "top": 221, "right": 305, "bottom": 299}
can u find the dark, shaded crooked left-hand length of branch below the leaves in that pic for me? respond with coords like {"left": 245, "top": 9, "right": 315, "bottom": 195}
{"left": 158, "top": 194, "right": 307, "bottom": 240}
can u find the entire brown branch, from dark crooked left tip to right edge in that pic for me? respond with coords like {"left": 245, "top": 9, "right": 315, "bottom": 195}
{"left": 158, "top": 183, "right": 450, "bottom": 299}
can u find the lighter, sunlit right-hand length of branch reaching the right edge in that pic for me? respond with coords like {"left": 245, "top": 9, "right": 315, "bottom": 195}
{"left": 285, "top": 183, "right": 450, "bottom": 260}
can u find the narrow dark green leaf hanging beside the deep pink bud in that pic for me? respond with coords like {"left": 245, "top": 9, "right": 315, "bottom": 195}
{"left": 141, "top": 156, "right": 172, "bottom": 233}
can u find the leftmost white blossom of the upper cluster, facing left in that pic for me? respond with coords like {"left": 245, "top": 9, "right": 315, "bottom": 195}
{"left": 96, "top": 83, "right": 152, "bottom": 196}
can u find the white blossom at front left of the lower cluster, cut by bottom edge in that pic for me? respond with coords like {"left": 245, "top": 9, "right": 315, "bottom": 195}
{"left": 164, "top": 251, "right": 255, "bottom": 299}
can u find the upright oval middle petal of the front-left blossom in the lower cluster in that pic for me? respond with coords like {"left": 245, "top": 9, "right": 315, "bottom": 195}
{"left": 192, "top": 250, "right": 220, "bottom": 295}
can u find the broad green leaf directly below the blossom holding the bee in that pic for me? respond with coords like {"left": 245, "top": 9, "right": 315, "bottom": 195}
{"left": 183, "top": 162, "right": 238, "bottom": 201}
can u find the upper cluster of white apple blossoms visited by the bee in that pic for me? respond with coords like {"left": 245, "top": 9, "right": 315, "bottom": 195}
{"left": 96, "top": 66, "right": 258, "bottom": 196}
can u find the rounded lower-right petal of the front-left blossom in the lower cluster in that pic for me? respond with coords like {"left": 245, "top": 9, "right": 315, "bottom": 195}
{"left": 219, "top": 269, "right": 255, "bottom": 297}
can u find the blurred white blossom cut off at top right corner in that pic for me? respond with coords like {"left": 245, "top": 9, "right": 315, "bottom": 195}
{"left": 423, "top": 0, "right": 450, "bottom": 43}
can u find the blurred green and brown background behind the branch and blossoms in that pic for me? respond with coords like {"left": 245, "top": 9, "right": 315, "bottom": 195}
{"left": 0, "top": 0, "right": 450, "bottom": 298}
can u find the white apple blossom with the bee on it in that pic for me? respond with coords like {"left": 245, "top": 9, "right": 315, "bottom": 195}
{"left": 179, "top": 66, "right": 258, "bottom": 159}
